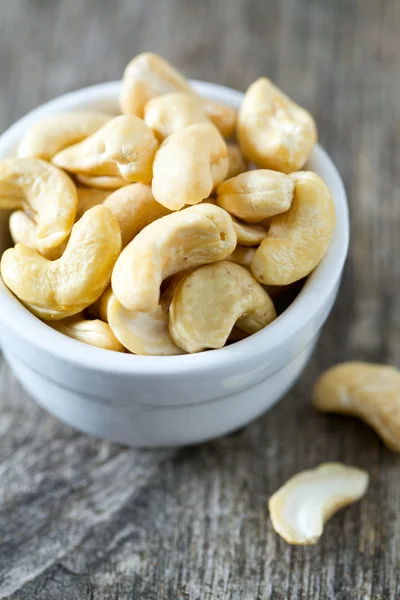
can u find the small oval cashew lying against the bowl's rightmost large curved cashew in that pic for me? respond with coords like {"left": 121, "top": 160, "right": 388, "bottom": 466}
{"left": 217, "top": 169, "right": 294, "bottom": 223}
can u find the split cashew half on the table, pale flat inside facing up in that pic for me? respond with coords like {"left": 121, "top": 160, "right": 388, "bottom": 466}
{"left": 268, "top": 463, "right": 369, "bottom": 545}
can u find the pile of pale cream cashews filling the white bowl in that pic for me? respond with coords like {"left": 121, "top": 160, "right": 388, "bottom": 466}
{"left": 0, "top": 53, "right": 335, "bottom": 355}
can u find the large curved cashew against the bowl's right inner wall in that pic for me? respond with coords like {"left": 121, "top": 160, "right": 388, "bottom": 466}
{"left": 251, "top": 171, "right": 336, "bottom": 285}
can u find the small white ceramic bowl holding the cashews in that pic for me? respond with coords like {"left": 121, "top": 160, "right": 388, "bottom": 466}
{"left": 0, "top": 81, "right": 349, "bottom": 447}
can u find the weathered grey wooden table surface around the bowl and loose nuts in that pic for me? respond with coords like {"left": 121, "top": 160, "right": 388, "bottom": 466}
{"left": 0, "top": 0, "right": 400, "bottom": 600}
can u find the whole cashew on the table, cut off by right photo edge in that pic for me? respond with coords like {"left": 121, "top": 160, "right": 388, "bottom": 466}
{"left": 313, "top": 362, "right": 400, "bottom": 452}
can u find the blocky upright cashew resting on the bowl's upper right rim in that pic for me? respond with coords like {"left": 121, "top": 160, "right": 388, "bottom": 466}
{"left": 237, "top": 77, "right": 317, "bottom": 173}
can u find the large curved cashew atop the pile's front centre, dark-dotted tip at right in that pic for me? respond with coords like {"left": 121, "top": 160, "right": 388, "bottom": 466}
{"left": 112, "top": 204, "right": 236, "bottom": 312}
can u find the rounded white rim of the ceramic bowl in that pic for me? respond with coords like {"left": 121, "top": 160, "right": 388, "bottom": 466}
{"left": 0, "top": 80, "right": 349, "bottom": 377}
